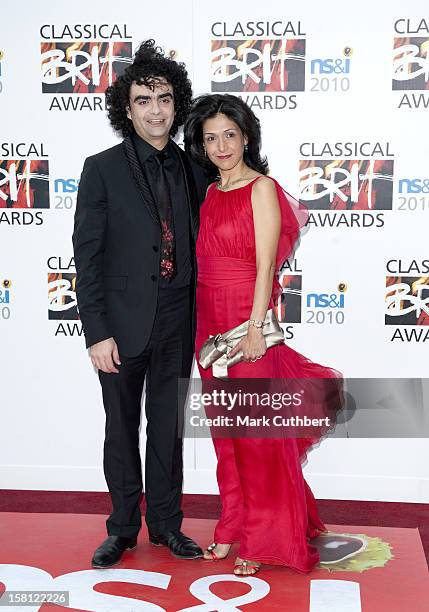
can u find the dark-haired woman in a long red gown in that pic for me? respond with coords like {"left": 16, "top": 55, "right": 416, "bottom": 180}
{"left": 185, "top": 94, "right": 340, "bottom": 575}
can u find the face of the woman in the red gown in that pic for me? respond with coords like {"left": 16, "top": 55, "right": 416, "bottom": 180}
{"left": 203, "top": 113, "right": 247, "bottom": 171}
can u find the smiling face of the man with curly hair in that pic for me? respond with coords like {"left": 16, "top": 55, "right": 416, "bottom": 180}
{"left": 127, "top": 78, "right": 174, "bottom": 149}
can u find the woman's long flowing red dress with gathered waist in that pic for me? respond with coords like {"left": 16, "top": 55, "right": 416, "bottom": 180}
{"left": 196, "top": 178, "right": 340, "bottom": 572}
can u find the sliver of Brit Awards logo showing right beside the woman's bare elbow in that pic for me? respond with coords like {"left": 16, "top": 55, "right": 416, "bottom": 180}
{"left": 275, "top": 259, "right": 302, "bottom": 340}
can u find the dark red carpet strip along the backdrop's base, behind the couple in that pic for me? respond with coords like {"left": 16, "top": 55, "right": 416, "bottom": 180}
{"left": 0, "top": 490, "right": 429, "bottom": 563}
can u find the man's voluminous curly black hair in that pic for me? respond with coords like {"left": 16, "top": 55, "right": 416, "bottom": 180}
{"left": 106, "top": 39, "right": 192, "bottom": 138}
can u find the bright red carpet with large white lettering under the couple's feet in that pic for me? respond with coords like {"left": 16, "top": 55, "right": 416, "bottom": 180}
{"left": 0, "top": 512, "right": 429, "bottom": 612}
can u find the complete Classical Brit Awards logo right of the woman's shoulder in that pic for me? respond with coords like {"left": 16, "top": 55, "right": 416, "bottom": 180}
{"left": 299, "top": 142, "right": 394, "bottom": 228}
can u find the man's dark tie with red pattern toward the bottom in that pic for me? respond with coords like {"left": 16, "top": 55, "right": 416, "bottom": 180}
{"left": 155, "top": 151, "right": 176, "bottom": 280}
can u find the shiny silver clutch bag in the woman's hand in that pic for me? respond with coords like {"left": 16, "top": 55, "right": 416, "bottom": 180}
{"left": 199, "top": 309, "right": 284, "bottom": 378}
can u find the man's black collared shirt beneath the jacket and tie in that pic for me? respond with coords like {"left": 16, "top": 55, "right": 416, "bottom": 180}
{"left": 133, "top": 134, "right": 192, "bottom": 289}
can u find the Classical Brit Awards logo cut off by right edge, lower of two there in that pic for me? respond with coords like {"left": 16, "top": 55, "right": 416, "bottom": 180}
{"left": 384, "top": 259, "right": 429, "bottom": 342}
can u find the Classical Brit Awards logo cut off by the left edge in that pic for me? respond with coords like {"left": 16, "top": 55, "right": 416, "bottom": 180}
{"left": 0, "top": 142, "right": 50, "bottom": 225}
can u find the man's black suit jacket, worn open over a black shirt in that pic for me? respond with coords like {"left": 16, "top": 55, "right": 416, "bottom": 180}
{"left": 73, "top": 139, "right": 207, "bottom": 357}
